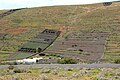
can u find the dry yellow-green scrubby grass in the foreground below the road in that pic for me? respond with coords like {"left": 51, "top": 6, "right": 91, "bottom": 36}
{"left": 0, "top": 68, "right": 120, "bottom": 80}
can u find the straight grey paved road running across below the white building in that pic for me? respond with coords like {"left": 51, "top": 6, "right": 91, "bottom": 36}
{"left": 0, "top": 64, "right": 120, "bottom": 69}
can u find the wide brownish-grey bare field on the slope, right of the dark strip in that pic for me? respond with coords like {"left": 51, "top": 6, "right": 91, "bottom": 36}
{"left": 44, "top": 32, "right": 109, "bottom": 62}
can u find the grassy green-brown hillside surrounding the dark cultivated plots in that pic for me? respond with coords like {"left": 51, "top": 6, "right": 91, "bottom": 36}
{"left": 0, "top": 2, "right": 120, "bottom": 63}
